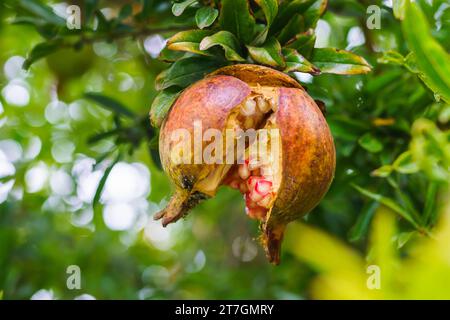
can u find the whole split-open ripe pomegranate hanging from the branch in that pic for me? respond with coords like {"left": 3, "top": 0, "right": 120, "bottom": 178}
{"left": 155, "top": 65, "right": 335, "bottom": 264}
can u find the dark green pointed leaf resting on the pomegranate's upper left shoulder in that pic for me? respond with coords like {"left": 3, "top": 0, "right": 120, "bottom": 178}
{"left": 161, "top": 57, "right": 227, "bottom": 89}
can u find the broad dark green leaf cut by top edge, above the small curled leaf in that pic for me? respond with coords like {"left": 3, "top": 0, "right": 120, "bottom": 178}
{"left": 219, "top": 0, "right": 255, "bottom": 43}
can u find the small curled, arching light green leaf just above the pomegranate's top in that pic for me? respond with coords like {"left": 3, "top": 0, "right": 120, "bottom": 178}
{"left": 200, "top": 31, "right": 245, "bottom": 61}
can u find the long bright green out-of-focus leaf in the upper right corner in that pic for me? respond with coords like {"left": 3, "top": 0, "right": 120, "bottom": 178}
{"left": 402, "top": 1, "right": 450, "bottom": 103}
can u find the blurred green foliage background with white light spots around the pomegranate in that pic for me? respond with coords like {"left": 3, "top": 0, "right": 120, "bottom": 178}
{"left": 0, "top": 0, "right": 450, "bottom": 299}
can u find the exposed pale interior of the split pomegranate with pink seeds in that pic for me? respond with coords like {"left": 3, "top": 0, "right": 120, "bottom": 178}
{"left": 195, "top": 86, "right": 281, "bottom": 221}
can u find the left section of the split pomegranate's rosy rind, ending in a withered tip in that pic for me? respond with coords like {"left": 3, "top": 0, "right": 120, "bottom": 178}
{"left": 155, "top": 75, "right": 251, "bottom": 226}
